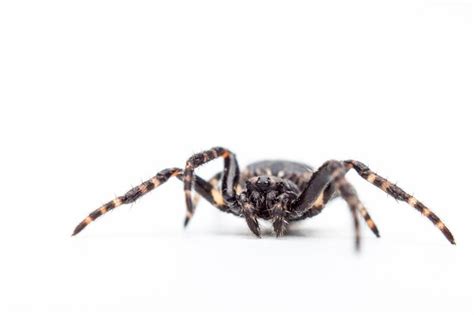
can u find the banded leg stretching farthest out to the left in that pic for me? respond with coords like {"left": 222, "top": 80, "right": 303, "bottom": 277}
{"left": 72, "top": 168, "right": 229, "bottom": 236}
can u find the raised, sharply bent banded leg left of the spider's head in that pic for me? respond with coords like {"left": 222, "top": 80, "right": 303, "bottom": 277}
{"left": 183, "top": 147, "right": 239, "bottom": 226}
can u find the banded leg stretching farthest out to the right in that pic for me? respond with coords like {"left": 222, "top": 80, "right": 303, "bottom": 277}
{"left": 344, "top": 160, "right": 456, "bottom": 244}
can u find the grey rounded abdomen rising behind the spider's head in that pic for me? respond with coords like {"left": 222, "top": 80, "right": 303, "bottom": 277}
{"left": 241, "top": 160, "right": 313, "bottom": 190}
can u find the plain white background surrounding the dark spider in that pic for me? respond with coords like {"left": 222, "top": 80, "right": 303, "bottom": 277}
{"left": 0, "top": 0, "right": 474, "bottom": 314}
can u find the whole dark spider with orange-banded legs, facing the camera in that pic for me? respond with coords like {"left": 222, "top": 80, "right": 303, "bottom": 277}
{"left": 73, "top": 147, "right": 455, "bottom": 248}
